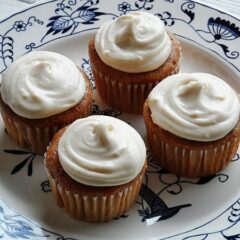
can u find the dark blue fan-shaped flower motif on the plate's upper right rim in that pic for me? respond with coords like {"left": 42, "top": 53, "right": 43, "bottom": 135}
{"left": 208, "top": 17, "right": 240, "bottom": 40}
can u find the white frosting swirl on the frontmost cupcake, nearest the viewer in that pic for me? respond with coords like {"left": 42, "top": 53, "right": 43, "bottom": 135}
{"left": 58, "top": 116, "right": 146, "bottom": 186}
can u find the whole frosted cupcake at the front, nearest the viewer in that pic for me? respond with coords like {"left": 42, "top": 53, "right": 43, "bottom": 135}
{"left": 45, "top": 116, "right": 146, "bottom": 222}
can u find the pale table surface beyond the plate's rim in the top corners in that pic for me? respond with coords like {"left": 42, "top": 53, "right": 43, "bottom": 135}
{"left": 0, "top": 0, "right": 240, "bottom": 18}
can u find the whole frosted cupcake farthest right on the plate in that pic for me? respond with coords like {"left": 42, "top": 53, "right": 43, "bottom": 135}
{"left": 143, "top": 73, "right": 240, "bottom": 177}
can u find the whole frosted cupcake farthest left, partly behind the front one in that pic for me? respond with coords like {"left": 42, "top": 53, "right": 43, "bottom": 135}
{"left": 0, "top": 51, "right": 93, "bottom": 153}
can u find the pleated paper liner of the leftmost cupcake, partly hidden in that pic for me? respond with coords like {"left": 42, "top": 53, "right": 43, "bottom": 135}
{"left": 2, "top": 112, "right": 59, "bottom": 153}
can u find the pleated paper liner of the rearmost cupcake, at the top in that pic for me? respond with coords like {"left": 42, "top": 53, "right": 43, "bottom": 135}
{"left": 92, "top": 66, "right": 179, "bottom": 113}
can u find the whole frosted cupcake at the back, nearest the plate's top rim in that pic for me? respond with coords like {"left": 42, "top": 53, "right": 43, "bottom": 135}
{"left": 89, "top": 12, "right": 181, "bottom": 113}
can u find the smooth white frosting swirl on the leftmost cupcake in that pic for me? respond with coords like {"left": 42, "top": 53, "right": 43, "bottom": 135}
{"left": 1, "top": 51, "right": 86, "bottom": 119}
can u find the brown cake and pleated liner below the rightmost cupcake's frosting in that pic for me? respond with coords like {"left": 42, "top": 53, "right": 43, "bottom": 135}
{"left": 143, "top": 101, "right": 240, "bottom": 177}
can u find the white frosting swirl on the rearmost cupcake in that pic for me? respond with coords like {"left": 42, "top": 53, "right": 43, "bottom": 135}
{"left": 95, "top": 12, "right": 171, "bottom": 73}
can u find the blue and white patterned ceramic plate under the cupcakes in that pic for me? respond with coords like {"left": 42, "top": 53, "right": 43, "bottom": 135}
{"left": 0, "top": 0, "right": 240, "bottom": 240}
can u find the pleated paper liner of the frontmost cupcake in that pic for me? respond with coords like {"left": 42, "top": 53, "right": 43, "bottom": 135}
{"left": 48, "top": 172, "right": 144, "bottom": 222}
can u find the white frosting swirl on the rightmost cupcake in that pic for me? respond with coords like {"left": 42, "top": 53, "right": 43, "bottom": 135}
{"left": 148, "top": 73, "right": 240, "bottom": 142}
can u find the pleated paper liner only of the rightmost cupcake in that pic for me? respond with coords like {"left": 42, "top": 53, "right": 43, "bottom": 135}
{"left": 147, "top": 125, "right": 240, "bottom": 177}
